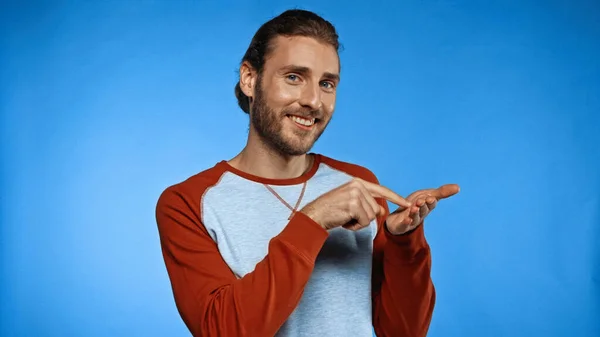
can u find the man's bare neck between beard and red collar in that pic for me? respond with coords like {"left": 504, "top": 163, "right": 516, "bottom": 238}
{"left": 229, "top": 131, "right": 313, "bottom": 179}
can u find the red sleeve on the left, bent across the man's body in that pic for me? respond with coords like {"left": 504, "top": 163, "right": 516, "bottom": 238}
{"left": 156, "top": 185, "right": 328, "bottom": 337}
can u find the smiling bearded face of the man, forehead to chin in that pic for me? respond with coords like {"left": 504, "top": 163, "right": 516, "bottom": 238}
{"left": 250, "top": 36, "right": 339, "bottom": 156}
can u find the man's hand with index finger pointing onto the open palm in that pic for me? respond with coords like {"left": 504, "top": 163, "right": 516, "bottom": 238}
{"left": 300, "top": 178, "right": 411, "bottom": 231}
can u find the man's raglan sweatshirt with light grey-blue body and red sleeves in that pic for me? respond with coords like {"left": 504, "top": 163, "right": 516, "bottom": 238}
{"left": 156, "top": 154, "right": 435, "bottom": 337}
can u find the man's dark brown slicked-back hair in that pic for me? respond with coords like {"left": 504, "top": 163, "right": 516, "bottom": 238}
{"left": 235, "top": 9, "right": 340, "bottom": 113}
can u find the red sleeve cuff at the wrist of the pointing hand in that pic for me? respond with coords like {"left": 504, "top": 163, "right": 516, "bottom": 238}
{"left": 279, "top": 212, "right": 329, "bottom": 263}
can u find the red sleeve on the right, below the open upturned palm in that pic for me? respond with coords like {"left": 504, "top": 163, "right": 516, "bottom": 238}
{"left": 373, "top": 189, "right": 435, "bottom": 337}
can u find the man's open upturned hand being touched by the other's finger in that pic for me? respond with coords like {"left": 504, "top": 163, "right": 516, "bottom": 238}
{"left": 386, "top": 184, "right": 460, "bottom": 235}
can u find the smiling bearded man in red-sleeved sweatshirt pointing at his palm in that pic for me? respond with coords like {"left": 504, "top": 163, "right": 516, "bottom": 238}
{"left": 156, "top": 10, "right": 458, "bottom": 337}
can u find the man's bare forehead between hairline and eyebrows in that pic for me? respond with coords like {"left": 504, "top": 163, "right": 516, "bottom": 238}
{"left": 265, "top": 36, "right": 340, "bottom": 74}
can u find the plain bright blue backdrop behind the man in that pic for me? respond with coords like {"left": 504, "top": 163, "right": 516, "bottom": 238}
{"left": 0, "top": 0, "right": 600, "bottom": 337}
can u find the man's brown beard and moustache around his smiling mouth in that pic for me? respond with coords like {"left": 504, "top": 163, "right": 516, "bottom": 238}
{"left": 250, "top": 78, "right": 329, "bottom": 156}
